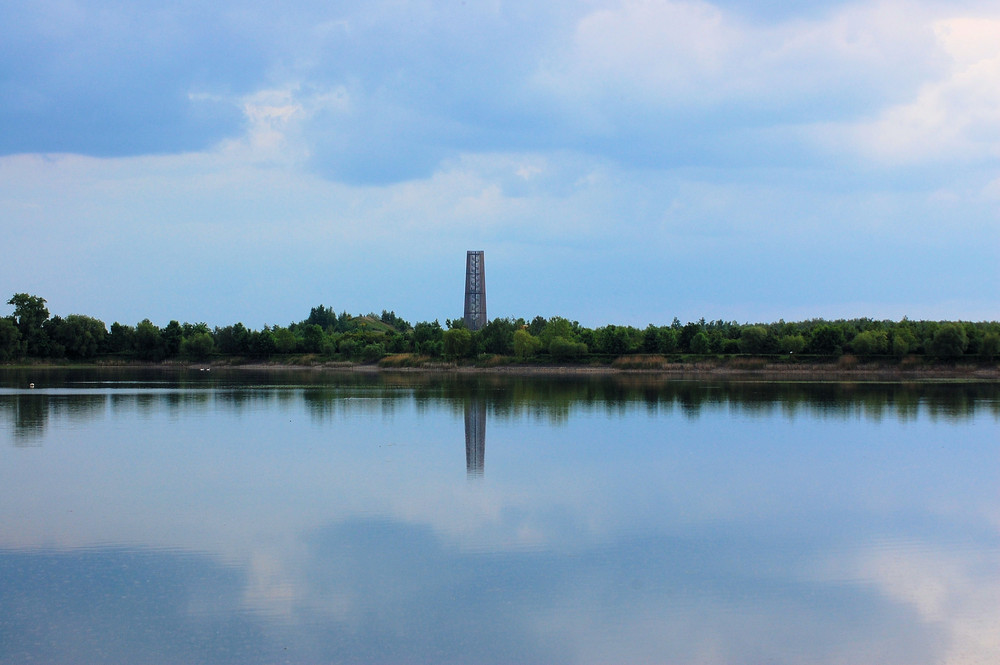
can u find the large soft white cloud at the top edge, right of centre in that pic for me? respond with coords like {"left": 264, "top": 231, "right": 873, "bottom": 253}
{"left": 538, "top": 0, "right": 938, "bottom": 115}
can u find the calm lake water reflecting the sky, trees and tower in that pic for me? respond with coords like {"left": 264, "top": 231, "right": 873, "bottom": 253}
{"left": 0, "top": 370, "right": 1000, "bottom": 665}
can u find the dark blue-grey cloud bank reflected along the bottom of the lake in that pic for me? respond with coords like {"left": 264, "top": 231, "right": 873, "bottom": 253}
{"left": 0, "top": 519, "right": 976, "bottom": 665}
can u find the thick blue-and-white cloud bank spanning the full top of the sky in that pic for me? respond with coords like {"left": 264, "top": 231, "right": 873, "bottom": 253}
{"left": 0, "top": 0, "right": 998, "bottom": 179}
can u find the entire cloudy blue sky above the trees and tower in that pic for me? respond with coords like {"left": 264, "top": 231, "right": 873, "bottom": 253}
{"left": 0, "top": 0, "right": 1000, "bottom": 328}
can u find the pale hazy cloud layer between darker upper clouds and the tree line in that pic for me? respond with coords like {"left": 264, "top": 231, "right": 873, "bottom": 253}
{"left": 0, "top": 130, "right": 997, "bottom": 327}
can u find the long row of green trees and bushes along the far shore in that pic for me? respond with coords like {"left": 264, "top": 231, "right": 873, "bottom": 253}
{"left": 0, "top": 293, "right": 1000, "bottom": 363}
